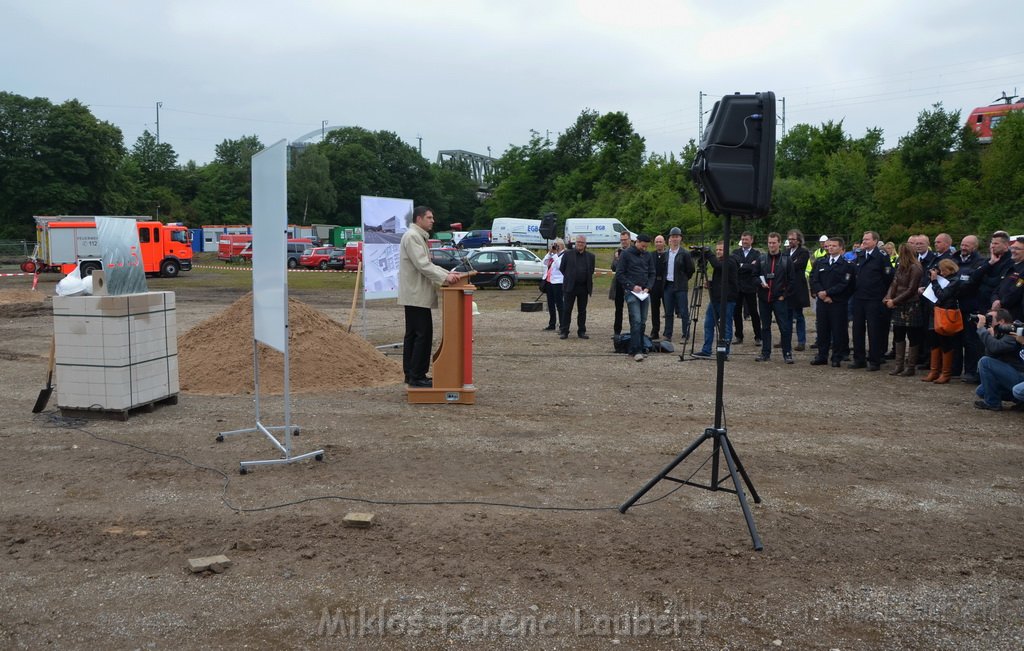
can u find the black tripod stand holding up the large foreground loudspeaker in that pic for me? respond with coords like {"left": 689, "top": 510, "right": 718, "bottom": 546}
{"left": 618, "top": 214, "right": 764, "bottom": 552}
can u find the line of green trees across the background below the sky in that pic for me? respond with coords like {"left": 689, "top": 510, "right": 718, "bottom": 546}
{"left": 0, "top": 92, "right": 1024, "bottom": 240}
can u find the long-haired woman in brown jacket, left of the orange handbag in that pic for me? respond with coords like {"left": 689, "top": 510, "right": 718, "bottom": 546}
{"left": 882, "top": 243, "right": 925, "bottom": 377}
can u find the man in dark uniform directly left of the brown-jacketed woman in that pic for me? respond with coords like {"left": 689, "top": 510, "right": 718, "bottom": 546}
{"left": 848, "top": 230, "right": 893, "bottom": 371}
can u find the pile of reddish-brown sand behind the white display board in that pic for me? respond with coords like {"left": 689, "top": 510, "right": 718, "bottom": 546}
{"left": 178, "top": 293, "right": 402, "bottom": 395}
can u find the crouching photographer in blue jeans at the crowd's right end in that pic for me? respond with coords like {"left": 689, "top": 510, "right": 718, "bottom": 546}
{"left": 972, "top": 308, "right": 1024, "bottom": 411}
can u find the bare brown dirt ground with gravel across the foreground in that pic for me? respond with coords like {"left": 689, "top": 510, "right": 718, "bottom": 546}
{"left": 0, "top": 272, "right": 1024, "bottom": 650}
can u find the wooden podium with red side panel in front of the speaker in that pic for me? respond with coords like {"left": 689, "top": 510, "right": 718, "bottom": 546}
{"left": 406, "top": 271, "right": 476, "bottom": 404}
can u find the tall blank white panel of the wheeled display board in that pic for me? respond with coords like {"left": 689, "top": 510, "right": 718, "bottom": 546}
{"left": 252, "top": 140, "right": 288, "bottom": 354}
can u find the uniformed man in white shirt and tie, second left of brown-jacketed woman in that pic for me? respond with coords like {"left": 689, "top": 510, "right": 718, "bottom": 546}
{"left": 811, "top": 237, "right": 853, "bottom": 367}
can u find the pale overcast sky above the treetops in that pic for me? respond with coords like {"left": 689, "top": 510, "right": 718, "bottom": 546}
{"left": 0, "top": 0, "right": 1024, "bottom": 164}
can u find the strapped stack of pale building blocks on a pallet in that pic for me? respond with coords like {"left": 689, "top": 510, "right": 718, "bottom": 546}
{"left": 53, "top": 292, "right": 178, "bottom": 411}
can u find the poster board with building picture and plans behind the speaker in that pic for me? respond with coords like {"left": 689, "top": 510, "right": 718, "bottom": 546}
{"left": 359, "top": 197, "right": 413, "bottom": 300}
